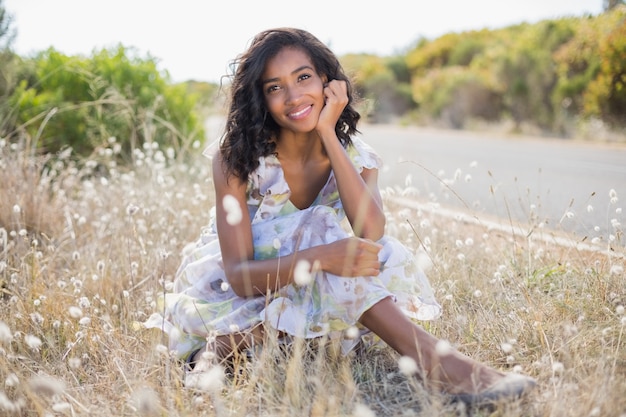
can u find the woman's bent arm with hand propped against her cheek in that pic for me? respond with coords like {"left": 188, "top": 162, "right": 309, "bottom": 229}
{"left": 317, "top": 80, "right": 385, "bottom": 241}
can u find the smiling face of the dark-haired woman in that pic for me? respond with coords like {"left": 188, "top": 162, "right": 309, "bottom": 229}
{"left": 262, "top": 47, "right": 326, "bottom": 133}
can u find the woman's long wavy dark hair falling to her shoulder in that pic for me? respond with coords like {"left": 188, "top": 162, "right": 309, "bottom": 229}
{"left": 220, "top": 28, "right": 361, "bottom": 182}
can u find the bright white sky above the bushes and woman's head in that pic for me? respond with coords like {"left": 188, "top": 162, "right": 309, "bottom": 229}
{"left": 3, "top": 0, "right": 603, "bottom": 81}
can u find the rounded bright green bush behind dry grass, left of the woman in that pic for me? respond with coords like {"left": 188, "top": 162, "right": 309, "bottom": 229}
{"left": 10, "top": 46, "right": 203, "bottom": 155}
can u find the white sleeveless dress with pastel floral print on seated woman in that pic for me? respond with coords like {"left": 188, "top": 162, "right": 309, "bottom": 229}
{"left": 145, "top": 138, "right": 441, "bottom": 358}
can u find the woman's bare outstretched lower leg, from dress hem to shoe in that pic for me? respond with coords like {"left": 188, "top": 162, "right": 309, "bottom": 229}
{"left": 360, "top": 298, "right": 504, "bottom": 394}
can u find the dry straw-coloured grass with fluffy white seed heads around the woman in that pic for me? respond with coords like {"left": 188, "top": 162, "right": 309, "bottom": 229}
{"left": 0, "top": 134, "right": 626, "bottom": 417}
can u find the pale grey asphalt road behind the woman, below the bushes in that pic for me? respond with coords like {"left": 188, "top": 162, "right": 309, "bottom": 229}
{"left": 361, "top": 125, "right": 626, "bottom": 238}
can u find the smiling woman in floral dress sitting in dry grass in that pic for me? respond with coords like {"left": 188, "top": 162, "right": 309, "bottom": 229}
{"left": 144, "top": 28, "right": 535, "bottom": 403}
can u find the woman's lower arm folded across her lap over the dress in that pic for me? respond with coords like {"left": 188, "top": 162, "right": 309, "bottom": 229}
{"left": 213, "top": 152, "right": 380, "bottom": 297}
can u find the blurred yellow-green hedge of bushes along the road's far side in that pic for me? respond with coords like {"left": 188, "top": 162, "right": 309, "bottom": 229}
{"left": 344, "top": 4, "right": 626, "bottom": 140}
